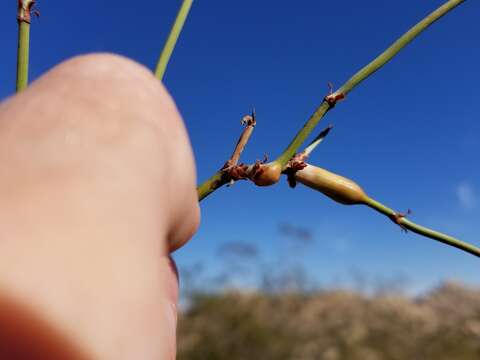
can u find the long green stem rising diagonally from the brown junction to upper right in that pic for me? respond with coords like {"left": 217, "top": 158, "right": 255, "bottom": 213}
{"left": 277, "top": 0, "right": 465, "bottom": 167}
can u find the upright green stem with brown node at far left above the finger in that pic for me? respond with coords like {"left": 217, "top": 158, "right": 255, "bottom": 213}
{"left": 16, "top": 0, "right": 35, "bottom": 92}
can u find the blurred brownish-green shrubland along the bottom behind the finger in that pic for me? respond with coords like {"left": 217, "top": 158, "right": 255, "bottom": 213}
{"left": 178, "top": 283, "right": 480, "bottom": 360}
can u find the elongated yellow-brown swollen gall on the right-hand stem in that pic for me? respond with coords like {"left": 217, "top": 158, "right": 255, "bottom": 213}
{"left": 295, "top": 164, "right": 368, "bottom": 205}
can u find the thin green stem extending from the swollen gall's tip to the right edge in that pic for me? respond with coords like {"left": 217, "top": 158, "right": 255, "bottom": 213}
{"left": 365, "top": 198, "right": 480, "bottom": 257}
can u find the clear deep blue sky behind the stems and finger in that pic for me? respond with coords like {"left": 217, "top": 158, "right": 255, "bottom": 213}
{"left": 0, "top": 0, "right": 480, "bottom": 290}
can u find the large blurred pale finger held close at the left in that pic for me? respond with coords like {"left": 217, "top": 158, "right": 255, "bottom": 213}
{"left": 0, "top": 54, "right": 199, "bottom": 359}
